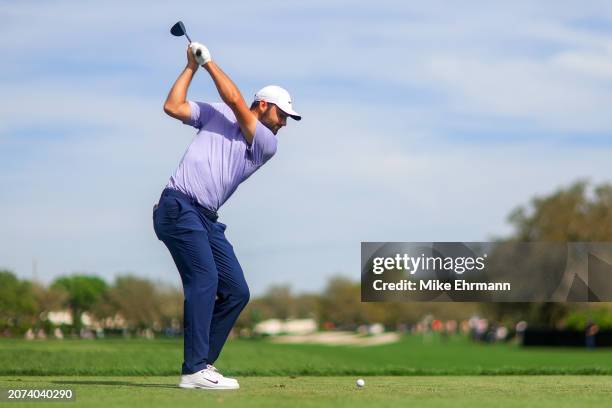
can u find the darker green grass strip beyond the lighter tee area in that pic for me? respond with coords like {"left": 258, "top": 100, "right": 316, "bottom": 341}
{"left": 0, "top": 336, "right": 612, "bottom": 376}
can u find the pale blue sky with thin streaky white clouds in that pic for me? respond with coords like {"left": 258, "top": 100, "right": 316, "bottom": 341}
{"left": 0, "top": 1, "right": 612, "bottom": 294}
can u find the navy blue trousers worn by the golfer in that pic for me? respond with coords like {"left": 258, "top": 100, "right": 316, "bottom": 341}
{"left": 153, "top": 188, "right": 249, "bottom": 374}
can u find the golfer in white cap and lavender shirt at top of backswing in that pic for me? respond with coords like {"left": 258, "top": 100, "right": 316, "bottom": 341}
{"left": 153, "top": 43, "right": 301, "bottom": 389}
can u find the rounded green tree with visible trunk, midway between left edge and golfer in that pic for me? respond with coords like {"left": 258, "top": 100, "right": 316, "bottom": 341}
{"left": 51, "top": 275, "right": 107, "bottom": 330}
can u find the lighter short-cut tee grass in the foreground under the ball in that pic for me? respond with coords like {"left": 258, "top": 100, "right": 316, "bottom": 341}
{"left": 0, "top": 376, "right": 612, "bottom": 408}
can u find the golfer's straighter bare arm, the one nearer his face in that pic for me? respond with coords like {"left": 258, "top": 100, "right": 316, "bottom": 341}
{"left": 203, "top": 61, "right": 257, "bottom": 145}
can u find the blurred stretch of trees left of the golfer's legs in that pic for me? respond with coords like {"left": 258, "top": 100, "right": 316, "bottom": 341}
{"left": 0, "top": 270, "right": 183, "bottom": 335}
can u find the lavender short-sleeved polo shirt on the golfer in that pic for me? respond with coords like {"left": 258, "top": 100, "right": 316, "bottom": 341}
{"left": 166, "top": 101, "right": 276, "bottom": 211}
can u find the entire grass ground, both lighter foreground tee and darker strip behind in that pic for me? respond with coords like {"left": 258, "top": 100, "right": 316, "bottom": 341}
{"left": 0, "top": 337, "right": 612, "bottom": 408}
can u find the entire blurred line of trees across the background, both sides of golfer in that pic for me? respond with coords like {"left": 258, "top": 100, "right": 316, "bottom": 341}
{"left": 0, "top": 181, "right": 612, "bottom": 335}
